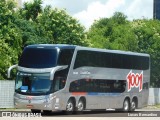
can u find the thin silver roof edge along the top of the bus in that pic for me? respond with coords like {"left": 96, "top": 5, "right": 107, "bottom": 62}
{"left": 27, "top": 44, "right": 150, "bottom": 57}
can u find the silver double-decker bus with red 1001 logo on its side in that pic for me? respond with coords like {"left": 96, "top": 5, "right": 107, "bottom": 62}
{"left": 8, "top": 44, "right": 150, "bottom": 113}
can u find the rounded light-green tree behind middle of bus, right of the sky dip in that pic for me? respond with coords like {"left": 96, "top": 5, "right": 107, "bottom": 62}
{"left": 88, "top": 12, "right": 137, "bottom": 51}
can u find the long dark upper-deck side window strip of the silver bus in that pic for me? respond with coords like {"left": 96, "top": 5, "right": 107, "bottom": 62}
{"left": 74, "top": 50, "right": 149, "bottom": 70}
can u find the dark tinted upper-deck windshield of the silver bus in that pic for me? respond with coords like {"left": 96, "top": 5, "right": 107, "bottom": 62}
{"left": 19, "top": 48, "right": 57, "bottom": 68}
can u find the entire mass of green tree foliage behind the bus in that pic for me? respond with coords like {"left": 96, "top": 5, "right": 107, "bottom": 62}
{"left": 0, "top": 0, "right": 160, "bottom": 87}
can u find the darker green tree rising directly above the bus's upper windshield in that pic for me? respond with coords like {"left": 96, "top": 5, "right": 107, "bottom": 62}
{"left": 15, "top": 0, "right": 49, "bottom": 49}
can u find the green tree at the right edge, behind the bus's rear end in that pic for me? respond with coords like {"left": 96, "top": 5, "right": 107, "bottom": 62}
{"left": 132, "top": 19, "right": 160, "bottom": 87}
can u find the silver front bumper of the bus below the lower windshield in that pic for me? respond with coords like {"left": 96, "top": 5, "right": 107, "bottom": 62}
{"left": 14, "top": 95, "right": 61, "bottom": 111}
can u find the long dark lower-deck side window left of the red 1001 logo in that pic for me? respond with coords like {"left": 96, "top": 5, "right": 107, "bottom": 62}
{"left": 69, "top": 79, "right": 126, "bottom": 93}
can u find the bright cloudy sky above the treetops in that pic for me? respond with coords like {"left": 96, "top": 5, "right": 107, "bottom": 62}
{"left": 22, "top": 0, "right": 153, "bottom": 29}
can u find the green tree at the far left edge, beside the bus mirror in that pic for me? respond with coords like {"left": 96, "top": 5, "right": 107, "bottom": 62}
{"left": 0, "top": 0, "right": 21, "bottom": 79}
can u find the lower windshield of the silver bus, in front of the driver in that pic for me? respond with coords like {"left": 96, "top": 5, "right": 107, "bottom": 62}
{"left": 15, "top": 73, "right": 51, "bottom": 94}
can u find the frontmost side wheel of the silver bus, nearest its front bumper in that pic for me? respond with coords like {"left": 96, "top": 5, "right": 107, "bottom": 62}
{"left": 66, "top": 99, "right": 75, "bottom": 114}
